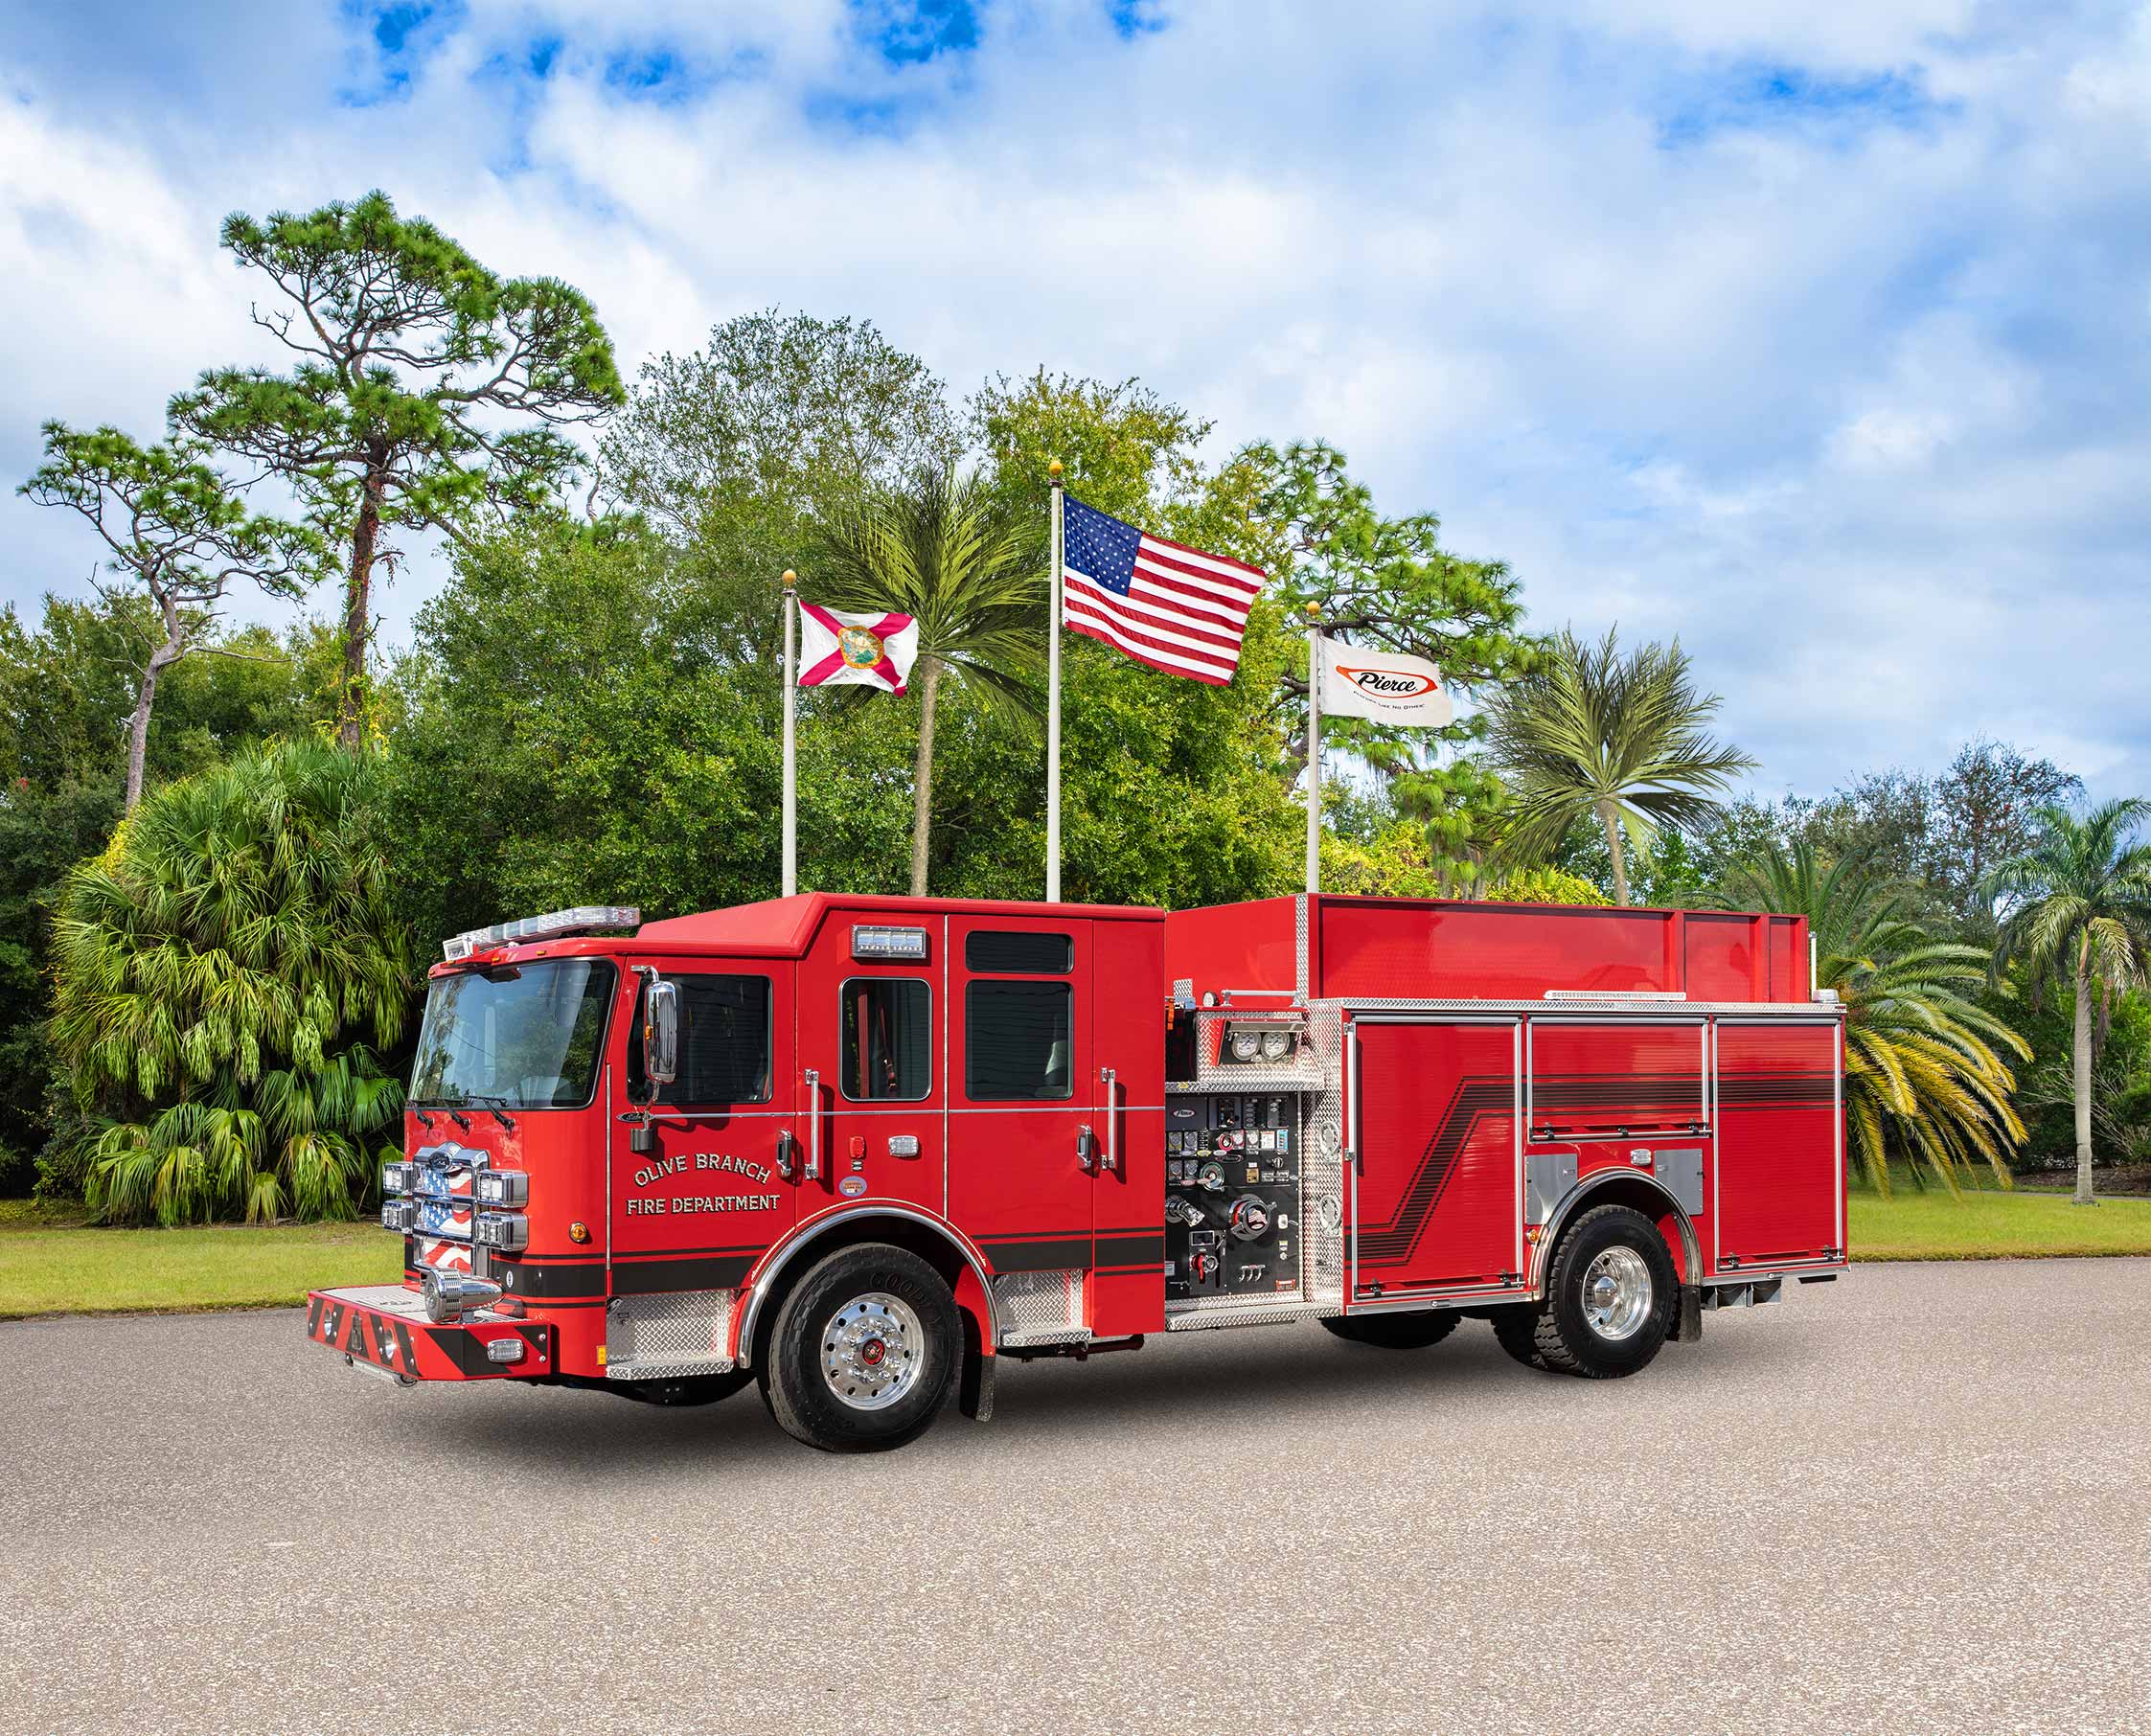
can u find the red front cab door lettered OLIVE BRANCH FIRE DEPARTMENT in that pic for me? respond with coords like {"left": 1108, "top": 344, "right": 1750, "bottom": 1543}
{"left": 608, "top": 957, "right": 800, "bottom": 1295}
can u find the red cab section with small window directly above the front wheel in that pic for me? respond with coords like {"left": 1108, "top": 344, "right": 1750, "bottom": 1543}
{"left": 798, "top": 917, "right": 947, "bottom": 1220}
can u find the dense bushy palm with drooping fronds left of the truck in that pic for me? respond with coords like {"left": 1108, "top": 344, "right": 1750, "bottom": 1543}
{"left": 52, "top": 742, "right": 411, "bottom": 1224}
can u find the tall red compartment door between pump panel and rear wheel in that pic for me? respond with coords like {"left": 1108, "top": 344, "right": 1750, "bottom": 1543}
{"left": 1349, "top": 1019, "right": 1525, "bottom": 1304}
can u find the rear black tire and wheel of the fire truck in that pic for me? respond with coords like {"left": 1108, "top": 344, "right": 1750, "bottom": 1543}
{"left": 1495, "top": 1204, "right": 1680, "bottom": 1382}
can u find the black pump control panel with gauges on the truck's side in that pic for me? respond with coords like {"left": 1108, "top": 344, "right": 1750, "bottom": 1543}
{"left": 1166, "top": 1093, "right": 1299, "bottom": 1301}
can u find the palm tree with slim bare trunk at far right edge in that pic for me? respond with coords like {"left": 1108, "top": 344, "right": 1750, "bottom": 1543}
{"left": 1983, "top": 800, "right": 2151, "bottom": 1204}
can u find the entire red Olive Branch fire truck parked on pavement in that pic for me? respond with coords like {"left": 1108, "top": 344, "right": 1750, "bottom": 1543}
{"left": 308, "top": 893, "right": 1845, "bottom": 1450}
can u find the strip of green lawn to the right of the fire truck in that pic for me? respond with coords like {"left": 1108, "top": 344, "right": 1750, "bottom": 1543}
{"left": 1845, "top": 1178, "right": 2151, "bottom": 1261}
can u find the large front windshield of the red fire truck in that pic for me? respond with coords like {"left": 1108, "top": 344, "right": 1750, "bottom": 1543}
{"left": 411, "top": 959, "right": 613, "bottom": 1110}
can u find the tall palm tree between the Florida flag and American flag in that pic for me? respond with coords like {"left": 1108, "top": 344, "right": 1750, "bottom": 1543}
{"left": 813, "top": 467, "right": 1045, "bottom": 897}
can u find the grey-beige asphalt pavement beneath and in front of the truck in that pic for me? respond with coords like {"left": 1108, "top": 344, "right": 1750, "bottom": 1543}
{"left": 0, "top": 1261, "right": 2151, "bottom": 1736}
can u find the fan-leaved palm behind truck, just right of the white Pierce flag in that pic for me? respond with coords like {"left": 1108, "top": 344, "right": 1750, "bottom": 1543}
{"left": 1486, "top": 628, "right": 1755, "bottom": 903}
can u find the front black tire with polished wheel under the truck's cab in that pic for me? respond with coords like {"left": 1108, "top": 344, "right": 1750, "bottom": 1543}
{"left": 762, "top": 1242, "right": 964, "bottom": 1452}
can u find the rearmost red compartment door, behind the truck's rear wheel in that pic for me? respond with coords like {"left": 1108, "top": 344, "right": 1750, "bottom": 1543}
{"left": 1712, "top": 1019, "right": 1845, "bottom": 1268}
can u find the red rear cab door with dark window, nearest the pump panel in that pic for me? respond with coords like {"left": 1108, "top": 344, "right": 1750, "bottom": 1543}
{"left": 949, "top": 914, "right": 1101, "bottom": 1282}
